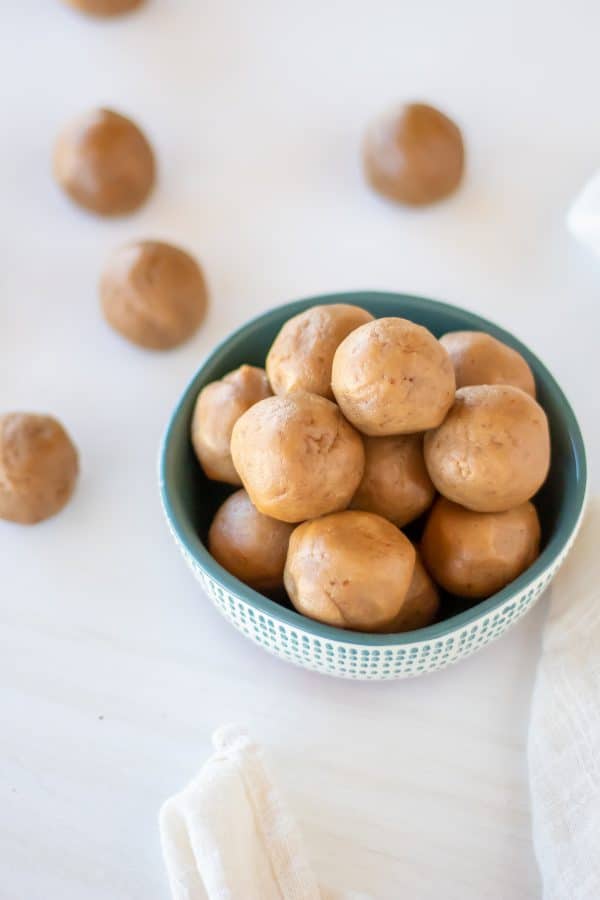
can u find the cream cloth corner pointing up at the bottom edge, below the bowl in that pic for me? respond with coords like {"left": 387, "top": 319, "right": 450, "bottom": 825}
{"left": 160, "top": 726, "right": 369, "bottom": 900}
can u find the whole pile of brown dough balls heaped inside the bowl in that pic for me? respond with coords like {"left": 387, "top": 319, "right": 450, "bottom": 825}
{"left": 191, "top": 304, "right": 550, "bottom": 633}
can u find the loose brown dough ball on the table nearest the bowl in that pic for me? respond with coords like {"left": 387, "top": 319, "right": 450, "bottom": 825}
{"left": 100, "top": 241, "right": 208, "bottom": 350}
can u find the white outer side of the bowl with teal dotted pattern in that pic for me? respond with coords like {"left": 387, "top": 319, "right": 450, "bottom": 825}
{"left": 164, "top": 523, "right": 578, "bottom": 681}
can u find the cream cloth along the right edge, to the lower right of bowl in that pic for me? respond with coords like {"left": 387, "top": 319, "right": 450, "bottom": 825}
{"left": 529, "top": 498, "right": 600, "bottom": 900}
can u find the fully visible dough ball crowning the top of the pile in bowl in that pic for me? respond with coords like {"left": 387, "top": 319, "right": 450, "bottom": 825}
{"left": 331, "top": 318, "right": 455, "bottom": 436}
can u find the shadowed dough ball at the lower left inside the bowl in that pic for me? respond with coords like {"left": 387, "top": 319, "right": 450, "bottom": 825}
{"left": 208, "top": 491, "right": 294, "bottom": 591}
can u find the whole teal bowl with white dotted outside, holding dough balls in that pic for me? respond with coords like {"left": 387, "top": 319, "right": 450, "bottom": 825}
{"left": 159, "top": 292, "right": 586, "bottom": 680}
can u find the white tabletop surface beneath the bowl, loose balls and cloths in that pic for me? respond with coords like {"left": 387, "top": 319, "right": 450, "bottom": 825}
{"left": 0, "top": 0, "right": 600, "bottom": 900}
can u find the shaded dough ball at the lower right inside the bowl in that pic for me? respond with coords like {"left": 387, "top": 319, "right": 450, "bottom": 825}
{"left": 421, "top": 497, "right": 540, "bottom": 600}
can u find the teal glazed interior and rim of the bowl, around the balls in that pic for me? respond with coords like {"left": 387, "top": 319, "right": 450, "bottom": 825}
{"left": 160, "top": 291, "right": 586, "bottom": 645}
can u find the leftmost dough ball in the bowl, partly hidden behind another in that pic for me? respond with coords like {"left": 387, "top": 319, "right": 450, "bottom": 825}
{"left": 192, "top": 366, "right": 271, "bottom": 485}
